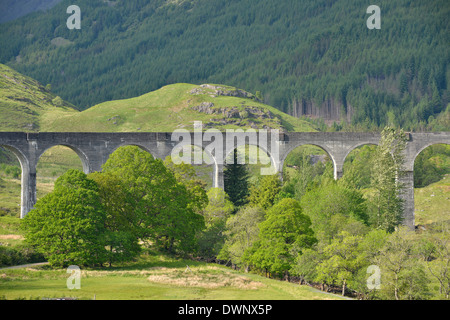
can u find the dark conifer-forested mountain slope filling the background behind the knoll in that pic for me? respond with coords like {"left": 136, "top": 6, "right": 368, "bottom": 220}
{"left": 0, "top": 0, "right": 450, "bottom": 130}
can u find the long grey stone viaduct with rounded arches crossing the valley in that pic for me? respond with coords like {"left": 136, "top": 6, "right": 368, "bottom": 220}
{"left": 0, "top": 131, "right": 450, "bottom": 228}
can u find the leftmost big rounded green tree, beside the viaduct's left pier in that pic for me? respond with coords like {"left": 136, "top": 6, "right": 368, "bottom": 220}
{"left": 22, "top": 170, "right": 108, "bottom": 266}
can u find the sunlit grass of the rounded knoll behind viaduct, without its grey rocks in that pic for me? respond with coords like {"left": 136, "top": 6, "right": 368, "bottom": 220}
{"left": 45, "top": 84, "right": 316, "bottom": 132}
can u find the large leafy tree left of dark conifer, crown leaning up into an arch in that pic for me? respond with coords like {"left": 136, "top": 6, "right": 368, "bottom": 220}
{"left": 103, "top": 146, "right": 204, "bottom": 253}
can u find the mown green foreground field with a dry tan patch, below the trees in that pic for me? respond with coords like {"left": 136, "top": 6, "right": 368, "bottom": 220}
{"left": 0, "top": 249, "right": 342, "bottom": 300}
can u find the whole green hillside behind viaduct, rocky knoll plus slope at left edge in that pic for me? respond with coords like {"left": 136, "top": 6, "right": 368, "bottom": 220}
{"left": 0, "top": 64, "right": 316, "bottom": 132}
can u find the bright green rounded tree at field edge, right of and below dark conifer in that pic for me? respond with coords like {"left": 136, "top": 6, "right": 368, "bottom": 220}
{"left": 246, "top": 198, "right": 317, "bottom": 278}
